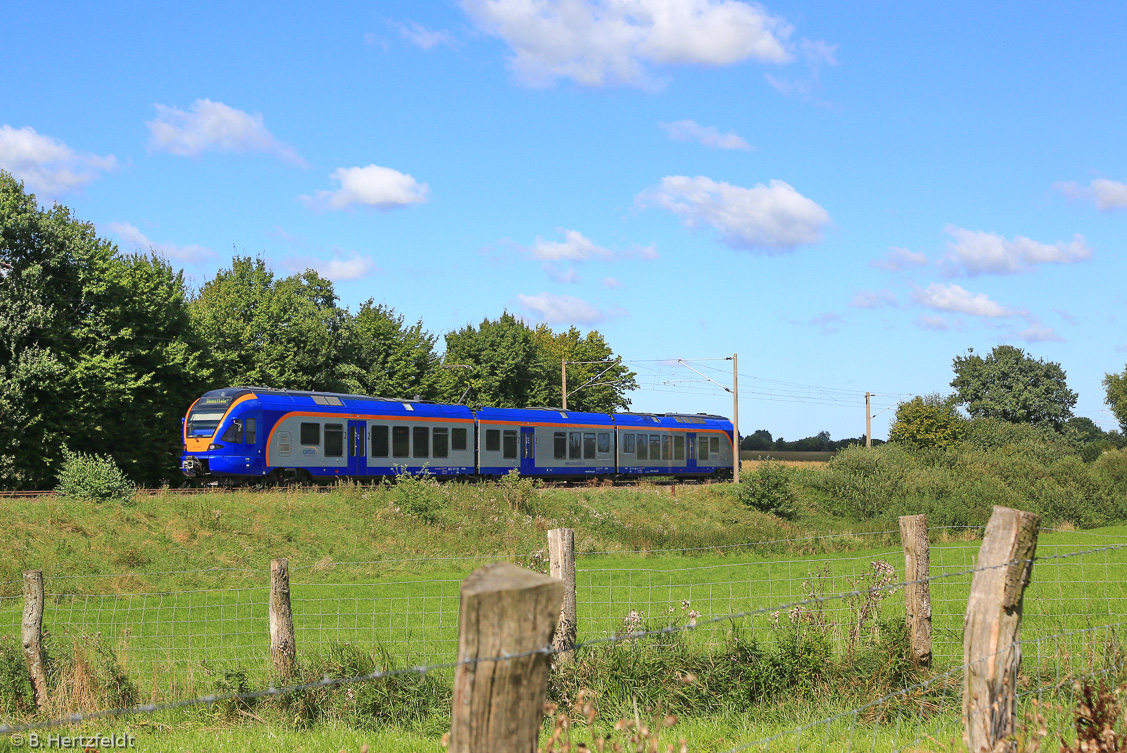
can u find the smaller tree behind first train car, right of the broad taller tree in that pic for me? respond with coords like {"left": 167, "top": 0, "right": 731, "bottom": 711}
{"left": 339, "top": 299, "right": 441, "bottom": 400}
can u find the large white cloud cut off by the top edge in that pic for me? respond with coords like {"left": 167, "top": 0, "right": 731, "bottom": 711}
{"left": 462, "top": 0, "right": 792, "bottom": 87}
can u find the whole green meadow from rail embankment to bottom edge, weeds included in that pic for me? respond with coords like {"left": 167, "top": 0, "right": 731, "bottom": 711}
{"left": 0, "top": 459, "right": 1127, "bottom": 751}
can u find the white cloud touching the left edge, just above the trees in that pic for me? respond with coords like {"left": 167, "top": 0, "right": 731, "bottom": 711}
{"left": 0, "top": 124, "right": 117, "bottom": 196}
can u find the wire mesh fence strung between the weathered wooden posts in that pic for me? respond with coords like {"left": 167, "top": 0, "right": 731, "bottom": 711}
{"left": 0, "top": 529, "right": 1127, "bottom": 751}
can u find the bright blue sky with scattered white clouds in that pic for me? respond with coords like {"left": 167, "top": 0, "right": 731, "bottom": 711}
{"left": 0, "top": 0, "right": 1127, "bottom": 438}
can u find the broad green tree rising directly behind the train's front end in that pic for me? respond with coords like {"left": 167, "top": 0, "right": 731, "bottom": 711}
{"left": 189, "top": 257, "right": 346, "bottom": 390}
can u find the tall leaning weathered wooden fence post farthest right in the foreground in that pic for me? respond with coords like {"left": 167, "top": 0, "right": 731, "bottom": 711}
{"left": 962, "top": 507, "right": 1041, "bottom": 753}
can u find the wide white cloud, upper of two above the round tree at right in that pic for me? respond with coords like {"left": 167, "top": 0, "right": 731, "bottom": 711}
{"left": 940, "top": 225, "right": 1092, "bottom": 277}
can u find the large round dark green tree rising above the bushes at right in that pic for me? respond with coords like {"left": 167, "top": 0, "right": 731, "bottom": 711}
{"left": 951, "top": 345, "right": 1076, "bottom": 432}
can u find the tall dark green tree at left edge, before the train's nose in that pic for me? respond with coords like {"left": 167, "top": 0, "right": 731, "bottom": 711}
{"left": 0, "top": 171, "right": 206, "bottom": 488}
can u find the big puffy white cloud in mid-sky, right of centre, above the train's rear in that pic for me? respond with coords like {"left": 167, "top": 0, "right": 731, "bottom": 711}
{"left": 635, "top": 175, "right": 829, "bottom": 254}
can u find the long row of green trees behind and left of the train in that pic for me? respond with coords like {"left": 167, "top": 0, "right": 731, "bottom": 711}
{"left": 0, "top": 170, "right": 637, "bottom": 489}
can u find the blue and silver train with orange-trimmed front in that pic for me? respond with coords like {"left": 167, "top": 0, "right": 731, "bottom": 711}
{"left": 180, "top": 387, "right": 733, "bottom": 486}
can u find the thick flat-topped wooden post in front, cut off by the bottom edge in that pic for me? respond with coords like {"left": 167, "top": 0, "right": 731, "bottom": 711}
{"left": 450, "top": 562, "right": 564, "bottom": 753}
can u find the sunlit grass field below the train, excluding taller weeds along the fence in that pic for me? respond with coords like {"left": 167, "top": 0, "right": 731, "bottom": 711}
{"left": 0, "top": 487, "right": 1127, "bottom": 751}
